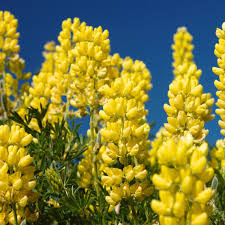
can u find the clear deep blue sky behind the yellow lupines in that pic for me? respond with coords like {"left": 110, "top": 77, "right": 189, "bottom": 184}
{"left": 1, "top": 0, "right": 225, "bottom": 144}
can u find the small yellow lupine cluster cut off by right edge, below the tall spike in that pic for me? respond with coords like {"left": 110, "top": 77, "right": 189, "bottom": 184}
{"left": 210, "top": 139, "right": 225, "bottom": 169}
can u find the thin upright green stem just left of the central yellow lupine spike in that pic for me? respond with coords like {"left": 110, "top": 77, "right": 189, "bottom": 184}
{"left": 90, "top": 108, "right": 99, "bottom": 198}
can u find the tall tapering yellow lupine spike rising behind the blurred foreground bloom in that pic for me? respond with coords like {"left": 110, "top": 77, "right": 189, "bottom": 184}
{"left": 149, "top": 27, "right": 214, "bottom": 172}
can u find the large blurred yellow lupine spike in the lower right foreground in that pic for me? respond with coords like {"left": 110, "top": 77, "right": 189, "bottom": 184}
{"left": 151, "top": 134, "right": 214, "bottom": 225}
